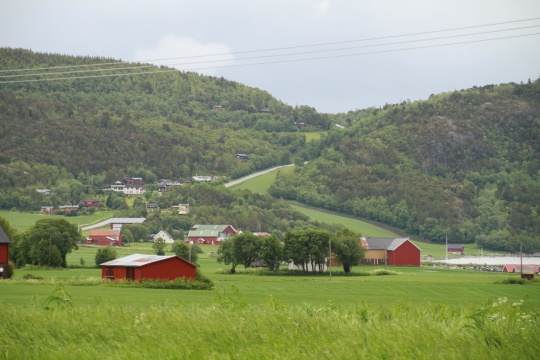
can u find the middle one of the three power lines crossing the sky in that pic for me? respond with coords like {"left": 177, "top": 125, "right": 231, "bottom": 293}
{"left": 0, "top": 25, "right": 540, "bottom": 78}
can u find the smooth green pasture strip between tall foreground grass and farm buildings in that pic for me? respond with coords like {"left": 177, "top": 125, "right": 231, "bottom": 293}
{"left": 4, "top": 243, "right": 540, "bottom": 306}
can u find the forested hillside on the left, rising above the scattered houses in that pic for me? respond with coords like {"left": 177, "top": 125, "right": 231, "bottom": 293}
{"left": 0, "top": 48, "right": 330, "bottom": 181}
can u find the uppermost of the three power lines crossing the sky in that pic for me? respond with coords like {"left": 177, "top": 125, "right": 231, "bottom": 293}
{"left": 0, "top": 18, "right": 540, "bottom": 73}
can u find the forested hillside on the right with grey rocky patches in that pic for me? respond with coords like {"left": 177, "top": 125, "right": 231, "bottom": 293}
{"left": 271, "top": 80, "right": 540, "bottom": 251}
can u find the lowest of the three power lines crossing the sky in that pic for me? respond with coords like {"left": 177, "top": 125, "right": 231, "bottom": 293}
{"left": 0, "top": 32, "right": 540, "bottom": 84}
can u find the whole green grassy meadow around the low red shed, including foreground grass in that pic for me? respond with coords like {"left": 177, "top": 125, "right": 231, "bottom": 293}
{"left": 0, "top": 243, "right": 540, "bottom": 359}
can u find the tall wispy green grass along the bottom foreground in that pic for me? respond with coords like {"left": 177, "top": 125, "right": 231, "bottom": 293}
{"left": 0, "top": 292, "right": 540, "bottom": 359}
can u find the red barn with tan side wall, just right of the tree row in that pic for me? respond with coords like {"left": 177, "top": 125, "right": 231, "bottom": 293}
{"left": 362, "top": 238, "right": 420, "bottom": 266}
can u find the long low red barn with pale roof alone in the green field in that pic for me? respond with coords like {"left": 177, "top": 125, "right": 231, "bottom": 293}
{"left": 100, "top": 254, "right": 197, "bottom": 281}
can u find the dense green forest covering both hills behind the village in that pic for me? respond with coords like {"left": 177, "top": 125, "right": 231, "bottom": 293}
{"left": 0, "top": 48, "right": 540, "bottom": 252}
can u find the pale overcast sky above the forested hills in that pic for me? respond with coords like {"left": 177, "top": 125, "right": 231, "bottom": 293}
{"left": 0, "top": 0, "right": 540, "bottom": 113}
